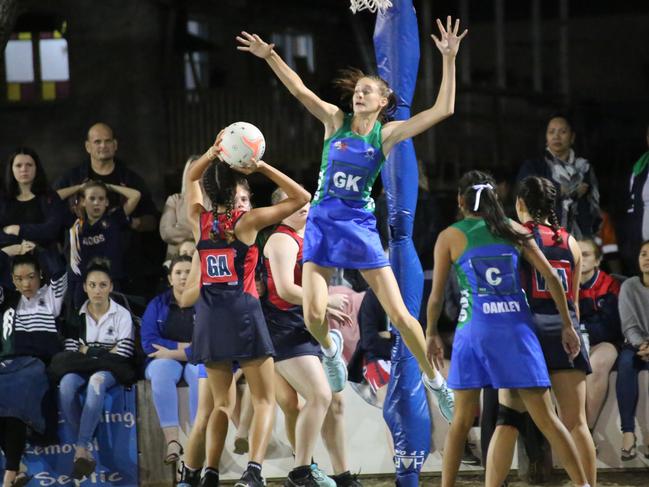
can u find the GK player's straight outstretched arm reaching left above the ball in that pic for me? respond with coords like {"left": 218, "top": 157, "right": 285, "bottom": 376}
{"left": 237, "top": 31, "right": 343, "bottom": 132}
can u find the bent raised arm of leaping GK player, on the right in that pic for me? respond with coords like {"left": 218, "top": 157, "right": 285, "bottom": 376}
{"left": 383, "top": 15, "right": 468, "bottom": 154}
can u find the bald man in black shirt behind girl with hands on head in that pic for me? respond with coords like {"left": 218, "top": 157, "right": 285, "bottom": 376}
{"left": 54, "top": 123, "right": 164, "bottom": 299}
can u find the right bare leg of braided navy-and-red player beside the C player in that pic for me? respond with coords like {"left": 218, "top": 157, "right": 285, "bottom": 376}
{"left": 550, "top": 370, "right": 597, "bottom": 487}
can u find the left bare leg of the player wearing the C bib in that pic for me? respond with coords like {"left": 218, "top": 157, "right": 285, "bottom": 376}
{"left": 440, "top": 388, "right": 480, "bottom": 487}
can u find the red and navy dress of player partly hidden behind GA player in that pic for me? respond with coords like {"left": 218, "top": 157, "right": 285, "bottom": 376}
{"left": 263, "top": 224, "right": 322, "bottom": 362}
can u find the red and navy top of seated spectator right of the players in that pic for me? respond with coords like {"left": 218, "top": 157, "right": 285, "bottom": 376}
{"left": 579, "top": 270, "right": 624, "bottom": 348}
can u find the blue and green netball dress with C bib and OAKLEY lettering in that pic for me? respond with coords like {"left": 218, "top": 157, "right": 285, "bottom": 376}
{"left": 448, "top": 218, "right": 550, "bottom": 389}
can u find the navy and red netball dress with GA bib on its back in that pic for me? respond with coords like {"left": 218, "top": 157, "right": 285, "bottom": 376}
{"left": 192, "top": 211, "right": 274, "bottom": 363}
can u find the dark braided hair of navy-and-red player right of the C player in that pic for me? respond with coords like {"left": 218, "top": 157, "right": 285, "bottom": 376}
{"left": 516, "top": 176, "right": 563, "bottom": 244}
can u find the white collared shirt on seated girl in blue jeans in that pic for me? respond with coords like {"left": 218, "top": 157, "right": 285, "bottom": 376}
{"left": 65, "top": 299, "right": 135, "bottom": 358}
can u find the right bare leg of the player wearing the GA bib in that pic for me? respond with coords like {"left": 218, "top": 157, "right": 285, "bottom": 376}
{"left": 242, "top": 357, "right": 275, "bottom": 464}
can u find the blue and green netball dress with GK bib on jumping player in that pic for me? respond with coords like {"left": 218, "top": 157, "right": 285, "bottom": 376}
{"left": 304, "top": 114, "right": 389, "bottom": 269}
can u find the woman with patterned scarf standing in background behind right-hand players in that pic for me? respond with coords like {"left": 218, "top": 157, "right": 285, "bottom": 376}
{"left": 516, "top": 115, "right": 600, "bottom": 239}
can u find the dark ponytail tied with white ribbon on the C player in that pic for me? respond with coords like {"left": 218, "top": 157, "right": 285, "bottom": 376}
{"left": 458, "top": 171, "right": 530, "bottom": 245}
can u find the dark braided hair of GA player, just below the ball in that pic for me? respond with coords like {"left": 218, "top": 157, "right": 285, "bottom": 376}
{"left": 203, "top": 162, "right": 249, "bottom": 243}
